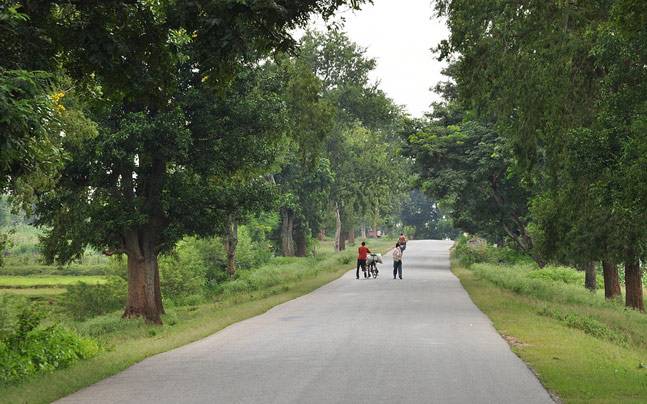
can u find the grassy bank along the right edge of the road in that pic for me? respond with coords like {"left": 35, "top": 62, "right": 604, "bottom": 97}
{"left": 452, "top": 260, "right": 647, "bottom": 403}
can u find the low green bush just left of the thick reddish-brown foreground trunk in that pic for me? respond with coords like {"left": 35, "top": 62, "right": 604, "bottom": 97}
{"left": 61, "top": 276, "right": 128, "bottom": 320}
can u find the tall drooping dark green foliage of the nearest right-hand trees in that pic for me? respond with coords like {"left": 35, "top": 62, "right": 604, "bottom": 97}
{"left": 436, "top": 0, "right": 647, "bottom": 310}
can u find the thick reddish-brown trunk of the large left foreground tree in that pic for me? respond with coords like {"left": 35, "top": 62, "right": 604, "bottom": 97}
{"left": 123, "top": 251, "right": 164, "bottom": 324}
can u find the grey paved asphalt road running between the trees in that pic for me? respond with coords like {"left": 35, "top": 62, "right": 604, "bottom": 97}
{"left": 62, "top": 241, "right": 552, "bottom": 404}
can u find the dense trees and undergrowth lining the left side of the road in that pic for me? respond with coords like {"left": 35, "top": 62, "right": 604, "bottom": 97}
{"left": 0, "top": 0, "right": 453, "bottom": 392}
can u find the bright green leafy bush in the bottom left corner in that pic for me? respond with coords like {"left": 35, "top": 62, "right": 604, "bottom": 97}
{"left": 0, "top": 306, "right": 99, "bottom": 385}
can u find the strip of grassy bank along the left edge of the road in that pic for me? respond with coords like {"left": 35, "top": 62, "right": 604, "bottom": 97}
{"left": 0, "top": 240, "right": 391, "bottom": 403}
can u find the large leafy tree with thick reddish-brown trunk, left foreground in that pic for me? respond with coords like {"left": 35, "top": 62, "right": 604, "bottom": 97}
{"left": 24, "top": 0, "right": 370, "bottom": 323}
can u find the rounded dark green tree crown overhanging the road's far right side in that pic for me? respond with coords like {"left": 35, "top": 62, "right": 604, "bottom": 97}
{"left": 405, "top": 110, "right": 540, "bottom": 262}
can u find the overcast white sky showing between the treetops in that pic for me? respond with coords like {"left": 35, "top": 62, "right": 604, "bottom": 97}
{"left": 308, "top": 0, "right": 448, "bottom": 116}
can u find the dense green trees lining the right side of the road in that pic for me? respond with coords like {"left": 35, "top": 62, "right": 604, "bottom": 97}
{"left": 405, "top": 0, "right": 647, "bottom": 311}
